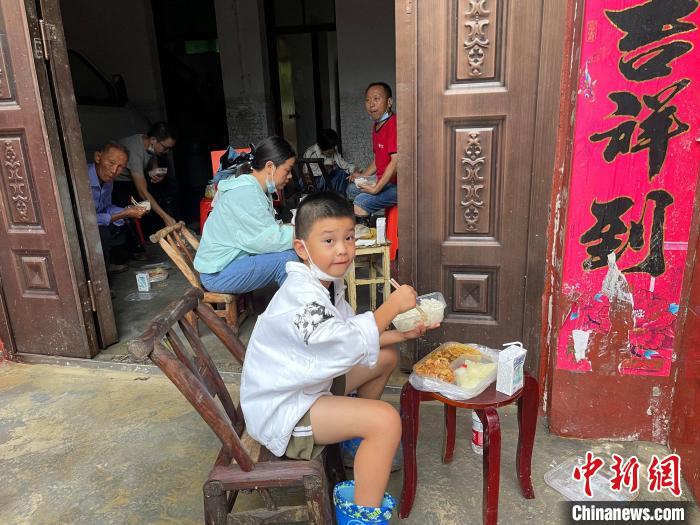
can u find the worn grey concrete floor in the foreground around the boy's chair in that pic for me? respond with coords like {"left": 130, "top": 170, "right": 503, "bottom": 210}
{"left": 0, "top": 363, "right": 698, "bottom": 525}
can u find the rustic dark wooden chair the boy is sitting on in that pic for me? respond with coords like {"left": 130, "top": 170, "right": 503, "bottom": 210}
{"left": 129, "top": 288, "right": 345, "bottom": 525}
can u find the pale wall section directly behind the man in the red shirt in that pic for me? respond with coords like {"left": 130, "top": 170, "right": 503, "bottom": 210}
{"left": 335, "top": 0, "right": 396, "bottom": 167}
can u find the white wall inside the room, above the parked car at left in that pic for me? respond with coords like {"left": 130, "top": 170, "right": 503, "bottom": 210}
{"left": 60, "top": 0, "right": 165, "bottom": 122}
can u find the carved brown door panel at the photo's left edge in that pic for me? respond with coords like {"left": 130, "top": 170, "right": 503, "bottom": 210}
{"left": 0, "top": 0, "right": 94, "bottom": 357}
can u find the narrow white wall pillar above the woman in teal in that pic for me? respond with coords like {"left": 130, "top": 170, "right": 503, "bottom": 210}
{"left": 214, "top": 0, "right": 274, "bottom": 146}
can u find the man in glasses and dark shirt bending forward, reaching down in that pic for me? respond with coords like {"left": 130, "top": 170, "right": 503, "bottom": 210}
{"left": 114, "top": 122, "right": 176, "bottom": 230}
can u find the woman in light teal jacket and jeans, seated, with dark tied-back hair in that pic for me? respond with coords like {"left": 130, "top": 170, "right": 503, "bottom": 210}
{"left": 194, "top": 137, "right": 298, "bottom": 294}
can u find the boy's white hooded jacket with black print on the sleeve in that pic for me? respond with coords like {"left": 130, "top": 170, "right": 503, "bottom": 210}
{"left": 241, "top": 262, "right": 379, "bottom": 456}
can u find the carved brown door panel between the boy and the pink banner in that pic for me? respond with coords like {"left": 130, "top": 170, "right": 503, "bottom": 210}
{"left": 417, "top": 0, "right": 542, "bottom": 351}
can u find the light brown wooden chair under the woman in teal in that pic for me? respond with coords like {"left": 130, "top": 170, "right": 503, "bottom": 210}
{"left": 150, "top": 221, "right": 248, "bottom": 334}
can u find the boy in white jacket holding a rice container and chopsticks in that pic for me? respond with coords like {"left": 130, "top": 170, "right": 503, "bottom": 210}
{"left": 241, "top": 192, "right": 437, "bottom": 507}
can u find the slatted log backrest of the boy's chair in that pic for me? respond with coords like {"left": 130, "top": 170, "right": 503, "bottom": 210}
{"left": 129, "top": 288, "right": 255, "bottom": 471}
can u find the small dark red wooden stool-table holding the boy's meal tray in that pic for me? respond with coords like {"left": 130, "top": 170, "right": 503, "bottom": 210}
{"left": 399, "top": 373, "right": 539, "bottom": 525}
